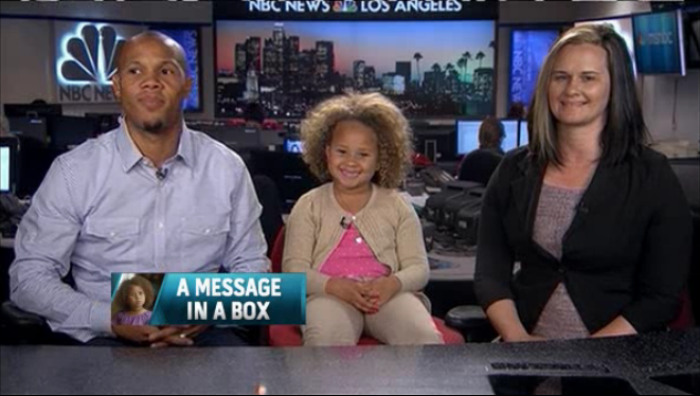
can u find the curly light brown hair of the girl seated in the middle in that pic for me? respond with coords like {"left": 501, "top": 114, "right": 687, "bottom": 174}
{"left": 301, "top": 93, "right": 413, "bottom": 189}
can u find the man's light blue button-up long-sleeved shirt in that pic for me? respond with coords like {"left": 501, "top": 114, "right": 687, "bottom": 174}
{"left": 10, "top": 123, "right": 269, "bottom": 342}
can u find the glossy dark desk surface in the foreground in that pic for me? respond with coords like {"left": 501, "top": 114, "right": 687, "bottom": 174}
{"left": 0, "top": 329, "right": 700, "bottom": 394}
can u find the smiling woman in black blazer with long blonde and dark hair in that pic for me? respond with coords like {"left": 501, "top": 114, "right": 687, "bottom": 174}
{"left": 475, "top": 26, "right": 692, "bottom": 342}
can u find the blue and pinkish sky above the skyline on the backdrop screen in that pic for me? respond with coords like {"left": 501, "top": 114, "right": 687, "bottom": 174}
{"left": 216, "top": 21, "right": 495, "bottom": 81}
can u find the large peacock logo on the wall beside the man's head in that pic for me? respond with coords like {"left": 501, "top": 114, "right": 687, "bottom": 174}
{"left": 57, "top": 23, "right": 125, "bottom": 85}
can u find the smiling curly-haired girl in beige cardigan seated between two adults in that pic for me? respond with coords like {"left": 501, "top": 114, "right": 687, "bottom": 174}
{"left": 283, "top": 94, "right": 443, "bottom": 346}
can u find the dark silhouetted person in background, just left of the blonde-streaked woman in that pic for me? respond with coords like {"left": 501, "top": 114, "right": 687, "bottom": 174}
{"left": 458, "top": 116, "right": 506, "bottom": 185}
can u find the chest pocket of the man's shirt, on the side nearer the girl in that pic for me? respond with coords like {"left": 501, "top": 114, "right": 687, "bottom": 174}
{"left": 179, "top": 213, "right": 231, "bottom": 268}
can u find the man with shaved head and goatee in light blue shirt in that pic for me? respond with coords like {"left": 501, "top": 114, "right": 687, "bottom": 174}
{"left": 10, "top": 32, "right": 269, "bottom": 347}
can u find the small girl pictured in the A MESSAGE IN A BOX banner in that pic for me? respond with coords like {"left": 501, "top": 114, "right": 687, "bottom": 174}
{"left": 112, "top": 275, "right": 154, "bottom": 326}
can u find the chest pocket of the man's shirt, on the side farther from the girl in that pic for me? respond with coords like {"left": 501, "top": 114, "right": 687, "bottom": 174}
{"left": 83, "top": 217, "right": 141, "bottom": 264}
